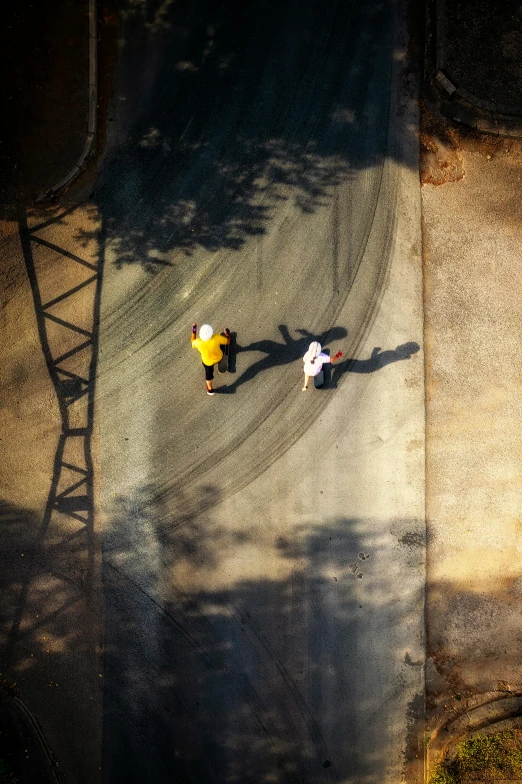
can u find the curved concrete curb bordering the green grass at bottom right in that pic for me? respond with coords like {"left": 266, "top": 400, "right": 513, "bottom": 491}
{"left": 426, "top": 692, "right": 522, "bottom": 781}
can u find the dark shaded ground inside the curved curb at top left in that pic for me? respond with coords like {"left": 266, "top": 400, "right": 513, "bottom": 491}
{"left": 0, "top": 0, "right": 89, "bottom": 217}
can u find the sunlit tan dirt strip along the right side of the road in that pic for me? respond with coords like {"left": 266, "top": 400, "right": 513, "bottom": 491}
{"left": 421, "top": 89, "right": 522, "bottom": 764}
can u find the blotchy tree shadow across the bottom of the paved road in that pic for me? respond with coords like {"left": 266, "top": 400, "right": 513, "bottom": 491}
{"left": 99, "top": 486, "right": 423, "bottom": 784}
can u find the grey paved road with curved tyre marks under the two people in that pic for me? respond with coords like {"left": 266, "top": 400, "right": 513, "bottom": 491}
{"left": 93, "top": 0, "right": 424, "bottom": 784}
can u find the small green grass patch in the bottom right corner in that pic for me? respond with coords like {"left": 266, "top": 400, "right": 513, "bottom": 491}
{"left": 430, "top": 730, "right": 522, "bottom": 784}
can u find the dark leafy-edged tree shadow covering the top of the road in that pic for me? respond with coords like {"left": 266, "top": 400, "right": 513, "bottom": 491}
{"left": 81, "top": 0, "right": 410, "bottom": 271}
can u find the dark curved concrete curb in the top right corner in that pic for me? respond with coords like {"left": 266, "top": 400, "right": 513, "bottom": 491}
{"left": 434, "top": 0, "right": 522, "bottom": 137}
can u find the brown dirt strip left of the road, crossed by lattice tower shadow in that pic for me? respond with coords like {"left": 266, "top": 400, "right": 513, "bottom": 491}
{"left": 0, "top": 178, "right": 101, "bottom": 784}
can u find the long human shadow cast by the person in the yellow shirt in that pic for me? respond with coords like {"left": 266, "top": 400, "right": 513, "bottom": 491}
{"left": 221, "top": 324, "right": 348, "bottom": 394}
